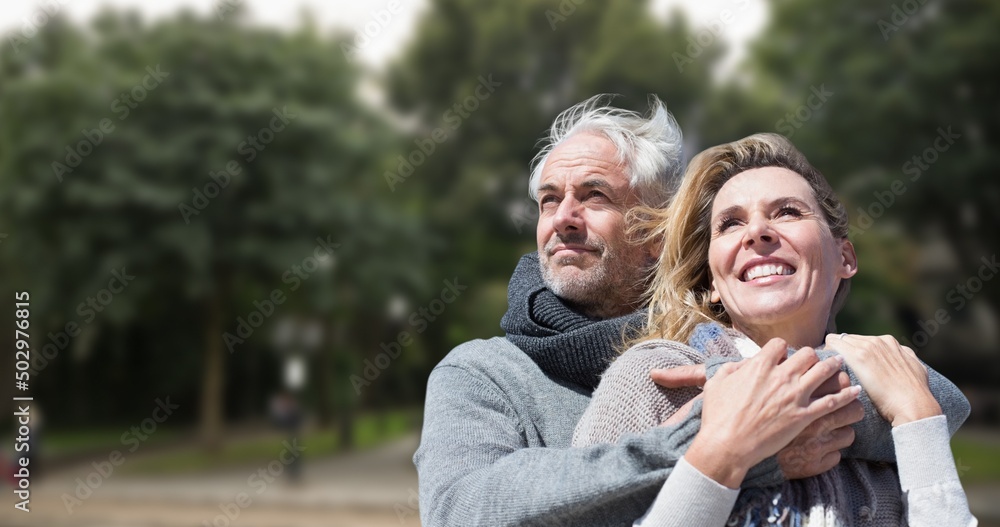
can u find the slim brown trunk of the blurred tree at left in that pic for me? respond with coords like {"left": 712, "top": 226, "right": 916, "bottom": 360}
{"left": 199, "top": 292, "right": 226, "bottom": 450}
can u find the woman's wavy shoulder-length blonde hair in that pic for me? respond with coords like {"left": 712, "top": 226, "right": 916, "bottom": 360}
{"left": 629, "top": 134, "right": 850, "bottom": 342}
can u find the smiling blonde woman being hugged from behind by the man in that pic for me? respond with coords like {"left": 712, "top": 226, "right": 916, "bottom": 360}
{"left": 573, "top": 134, "right": 976, "bottom": 527}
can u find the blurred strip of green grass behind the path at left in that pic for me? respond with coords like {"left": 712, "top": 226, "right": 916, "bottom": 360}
{"left": 46, "top": 410, "right": 419, "bottom": 475}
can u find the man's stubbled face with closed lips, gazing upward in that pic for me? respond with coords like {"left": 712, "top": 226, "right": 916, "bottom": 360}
{"left": 536, "top": 133, "right": 652, "bottom": 318}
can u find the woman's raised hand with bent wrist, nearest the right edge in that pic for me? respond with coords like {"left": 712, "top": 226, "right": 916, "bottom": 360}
{"left": 826, "top": 334, "right": 941, "bottom": 427}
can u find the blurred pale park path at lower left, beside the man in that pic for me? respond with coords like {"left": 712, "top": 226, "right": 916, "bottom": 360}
{"left": 0, "top": 434, "right": 420, "bottom": 527}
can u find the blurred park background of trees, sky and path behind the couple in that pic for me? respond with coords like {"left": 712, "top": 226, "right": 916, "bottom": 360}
{"left": 0, "top": 0, "right": 1000, "bottom": 527}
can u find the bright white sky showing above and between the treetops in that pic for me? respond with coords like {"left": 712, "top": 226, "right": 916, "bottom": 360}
{"left": 0, "top": 0, "right": 767, "bottom": 71}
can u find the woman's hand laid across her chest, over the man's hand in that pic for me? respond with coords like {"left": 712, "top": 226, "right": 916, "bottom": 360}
{"left": 684, "top": 339, "right": 860, "bottom": 489}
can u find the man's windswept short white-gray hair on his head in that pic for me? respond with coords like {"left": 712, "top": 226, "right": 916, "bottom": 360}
{"left": 528, "top": 94, "right": 683, "bottom": 207}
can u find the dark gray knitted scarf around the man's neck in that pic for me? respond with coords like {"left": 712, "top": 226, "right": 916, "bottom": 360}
{"left": 500, "top": 253, "right": 644, "bottom": 390}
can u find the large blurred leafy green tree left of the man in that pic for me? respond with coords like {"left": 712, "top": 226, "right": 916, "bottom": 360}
{"left": 0, "top": 4, "right": 425, "bottom": 445}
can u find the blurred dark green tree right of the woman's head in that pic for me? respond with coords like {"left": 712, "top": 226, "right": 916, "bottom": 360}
{"left": 710, "top": 0, "right": 1000, "bottom": 383}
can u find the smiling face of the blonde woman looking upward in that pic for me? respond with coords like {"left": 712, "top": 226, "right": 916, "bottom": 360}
{"left": 708, "top": 167, "right": 857, "bottom": 344}
